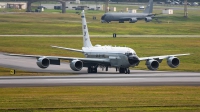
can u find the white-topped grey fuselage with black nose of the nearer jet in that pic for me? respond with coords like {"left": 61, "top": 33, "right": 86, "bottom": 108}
{"left": 82, "top": 45, "right": 139, "bottom": 68}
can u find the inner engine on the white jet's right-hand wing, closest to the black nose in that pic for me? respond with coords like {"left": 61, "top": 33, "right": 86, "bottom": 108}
{"left": 146, "top": 59, "right": 159, "bottom": 70}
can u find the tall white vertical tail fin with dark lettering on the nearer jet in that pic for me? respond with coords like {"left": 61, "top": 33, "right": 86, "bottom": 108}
{"left": 81, "top": 10, "right": 92, "bottom": 47}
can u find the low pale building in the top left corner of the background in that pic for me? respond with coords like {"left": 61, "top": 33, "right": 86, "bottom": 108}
{"left": 0, "top": 2, "right": 27, "bottom": 9}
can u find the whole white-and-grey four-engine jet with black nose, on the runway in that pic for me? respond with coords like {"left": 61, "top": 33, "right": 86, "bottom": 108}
{"left": 6, "top": 10, "right": 190, "bottom": 74}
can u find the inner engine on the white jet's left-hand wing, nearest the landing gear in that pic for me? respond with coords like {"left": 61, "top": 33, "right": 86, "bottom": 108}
{"left": 70, "top": 60, "right": 83, "bottom": 71}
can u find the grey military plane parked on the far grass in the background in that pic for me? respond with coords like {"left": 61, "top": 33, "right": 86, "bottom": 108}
{"left": 101, "top": 0, "right": 155, "bottom": 23}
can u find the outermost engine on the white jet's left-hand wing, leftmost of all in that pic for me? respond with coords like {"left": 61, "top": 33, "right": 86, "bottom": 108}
{"left": 36, "top": 57, "right": 50, "bottom": 68}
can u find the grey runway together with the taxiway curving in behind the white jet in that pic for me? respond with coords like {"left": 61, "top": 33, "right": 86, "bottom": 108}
{"left": 0, "top": 54, "right": 200, "bottom": 87}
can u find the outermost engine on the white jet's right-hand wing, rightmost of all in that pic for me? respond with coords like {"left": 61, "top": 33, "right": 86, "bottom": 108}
{"left": 167, "top": 57, "right": 180, "bottom": 68}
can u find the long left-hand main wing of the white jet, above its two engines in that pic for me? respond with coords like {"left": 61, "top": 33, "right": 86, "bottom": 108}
{"left": 4, "top": 54, "right": 110, "bottom": 63}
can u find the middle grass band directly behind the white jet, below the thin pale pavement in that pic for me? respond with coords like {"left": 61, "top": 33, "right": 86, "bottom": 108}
{"left": 0, "top": 37, "right": 200, "bottom": 72}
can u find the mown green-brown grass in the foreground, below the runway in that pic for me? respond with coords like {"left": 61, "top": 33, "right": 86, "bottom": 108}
{"left": 0, "top": 86, "right": 200, "bottom": 112}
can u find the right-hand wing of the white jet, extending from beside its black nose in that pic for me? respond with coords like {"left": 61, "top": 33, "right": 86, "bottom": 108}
{"left": 139, "top": 53, "right": 190, "bottom": 61}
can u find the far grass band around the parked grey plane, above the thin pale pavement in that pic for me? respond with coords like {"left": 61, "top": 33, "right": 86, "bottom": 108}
{"left": 0, "top": 10, "right": 200, "bottom": 35}
